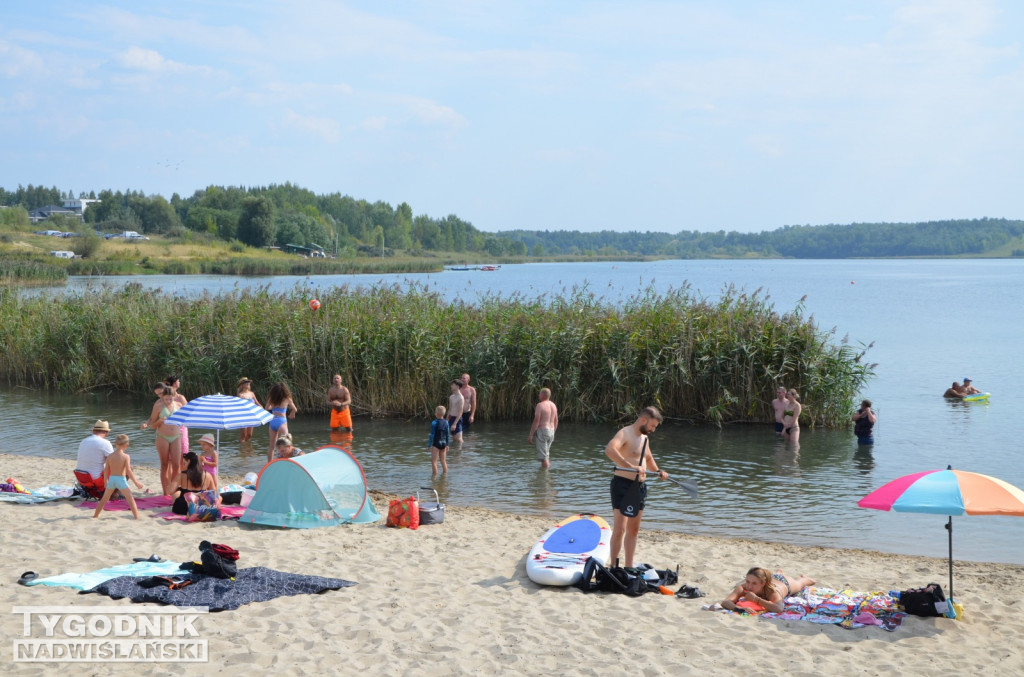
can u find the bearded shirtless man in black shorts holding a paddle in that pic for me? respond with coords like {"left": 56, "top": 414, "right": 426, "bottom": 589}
{"left": 604, "top": 407, "right": 669, "bottom": 566}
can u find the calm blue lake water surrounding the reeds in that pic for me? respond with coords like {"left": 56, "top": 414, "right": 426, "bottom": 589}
{"left": 0, "top": 260, "right": 1024, "bottom": 561}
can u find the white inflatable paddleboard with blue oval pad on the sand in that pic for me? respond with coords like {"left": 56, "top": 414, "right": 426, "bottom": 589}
{"left": 526, "top": 513, "right": 611, "bottom": 586}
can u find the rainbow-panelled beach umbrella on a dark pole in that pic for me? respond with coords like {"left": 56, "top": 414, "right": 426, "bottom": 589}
{"left": 857, "top": 466, "right": 1024, "bottom": 599}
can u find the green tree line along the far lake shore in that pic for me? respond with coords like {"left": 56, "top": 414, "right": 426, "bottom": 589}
{"left": 0, "top": 183, "right": 1024, "bottom": 259}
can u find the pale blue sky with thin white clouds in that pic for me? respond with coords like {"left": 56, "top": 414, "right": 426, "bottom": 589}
{"left": 0, "top": 0, "right": 1024, "bottom": 232}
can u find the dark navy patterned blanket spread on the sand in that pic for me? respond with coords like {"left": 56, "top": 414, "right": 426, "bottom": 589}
{"left": 81, "top": 566, "right": 355, "bottom": 611}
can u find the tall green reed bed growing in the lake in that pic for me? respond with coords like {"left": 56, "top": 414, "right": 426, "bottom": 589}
{"left": 0, "top": 285, "right": 873, "bottom": 426}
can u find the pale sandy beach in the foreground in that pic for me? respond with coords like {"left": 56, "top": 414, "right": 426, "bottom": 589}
{"left": 0, "top": 455, "right": 1024, "bottom": 676}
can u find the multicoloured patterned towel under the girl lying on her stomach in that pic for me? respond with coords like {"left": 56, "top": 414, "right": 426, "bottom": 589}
{"left": 703, "top": 588, "right": 906, "bottom": 632}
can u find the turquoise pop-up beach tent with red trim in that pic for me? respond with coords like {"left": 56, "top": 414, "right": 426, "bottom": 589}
{"left": 241, "top": 445, "right": 381, "bottom": 528}
